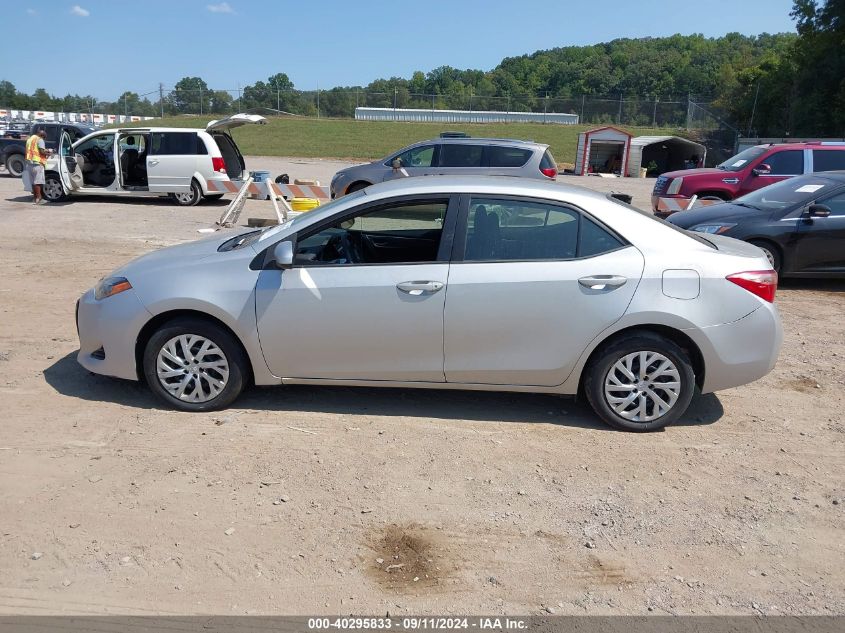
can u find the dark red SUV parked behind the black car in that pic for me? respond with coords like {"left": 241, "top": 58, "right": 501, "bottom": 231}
{"left": 651, "top": 142, "right": 845, "bottom": 210}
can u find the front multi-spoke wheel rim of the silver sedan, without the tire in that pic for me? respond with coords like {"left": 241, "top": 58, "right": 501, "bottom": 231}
{"left": 156, "top": 334, "right": 229, "bottom": 403}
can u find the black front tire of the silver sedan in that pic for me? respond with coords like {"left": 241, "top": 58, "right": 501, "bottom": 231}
{"left": 143, "top": 317, "right": 249, "bottom": 412}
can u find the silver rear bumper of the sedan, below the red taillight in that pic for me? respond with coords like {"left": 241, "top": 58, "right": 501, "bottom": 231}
{"left": 685, "top": 303, "right": 783, "bottom": 393}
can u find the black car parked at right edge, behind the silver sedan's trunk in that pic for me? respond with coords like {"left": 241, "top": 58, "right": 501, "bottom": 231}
{"left": 669, "top": 171, "right": 845, "bottom": 277}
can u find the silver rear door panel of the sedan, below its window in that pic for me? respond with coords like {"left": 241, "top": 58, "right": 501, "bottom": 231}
{"left": 444, "top": 247, "right": 643, "bottom": 386}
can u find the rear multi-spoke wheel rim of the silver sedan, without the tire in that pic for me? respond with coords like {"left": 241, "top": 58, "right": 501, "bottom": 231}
{"left": 604, "top": 351, "right": 681, "bottom": 422}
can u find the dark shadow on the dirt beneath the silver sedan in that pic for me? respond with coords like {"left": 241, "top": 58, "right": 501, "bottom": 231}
{"left": 44, "top": 352, "right": 724, "bottom": 431}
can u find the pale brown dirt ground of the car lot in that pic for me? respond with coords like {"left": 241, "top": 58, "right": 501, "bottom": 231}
{"left": 0, "top": 159, "right": 845, "bottom": 615}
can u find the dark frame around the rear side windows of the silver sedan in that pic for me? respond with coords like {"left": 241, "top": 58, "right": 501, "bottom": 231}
{"left": 451, "top": 193, "right": 632, "bottom": 264}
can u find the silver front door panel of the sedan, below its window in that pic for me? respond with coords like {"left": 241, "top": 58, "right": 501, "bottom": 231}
{"left": 256, "top": 263, "right": 449, "bottom": 382}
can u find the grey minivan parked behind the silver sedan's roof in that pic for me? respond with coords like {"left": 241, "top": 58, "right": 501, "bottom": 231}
{"left": 331, "top": 133, "right": 557, "bottom": 198}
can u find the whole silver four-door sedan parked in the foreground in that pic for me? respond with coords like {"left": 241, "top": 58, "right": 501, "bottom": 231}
{"left": 76, "top": 177, "right": 782, "bottom": 431}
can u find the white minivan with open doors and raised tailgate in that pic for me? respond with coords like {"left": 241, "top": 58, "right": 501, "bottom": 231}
{"left": 44, "top": 114, "right": 267, "bottom": 206}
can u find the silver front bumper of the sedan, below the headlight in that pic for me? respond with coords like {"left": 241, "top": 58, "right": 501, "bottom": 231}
{"left": 76, "top": 289, "right": 152, "bottom": 380}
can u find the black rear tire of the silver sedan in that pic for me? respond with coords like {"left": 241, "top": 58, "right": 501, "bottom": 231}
{"left": 584, "top": 332, "right": 695, "bottom": 431}
